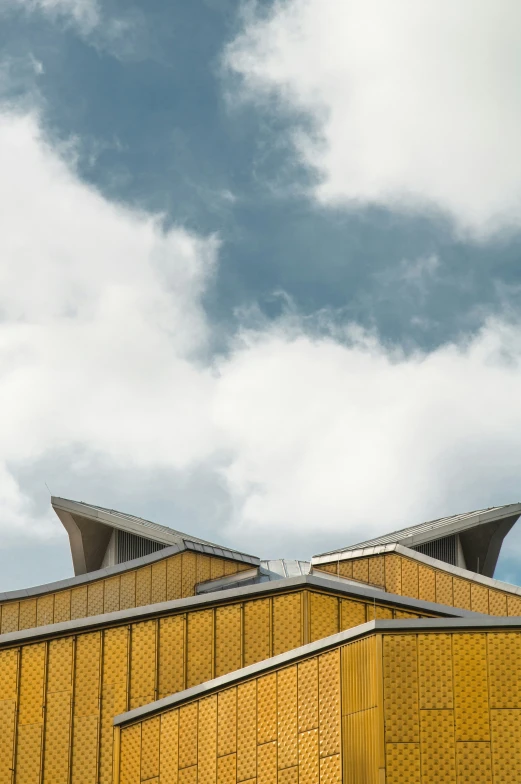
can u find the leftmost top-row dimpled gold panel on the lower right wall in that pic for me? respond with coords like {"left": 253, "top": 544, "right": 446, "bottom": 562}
{"left": 383, "top": 634, "right": 420, "bottom": 743}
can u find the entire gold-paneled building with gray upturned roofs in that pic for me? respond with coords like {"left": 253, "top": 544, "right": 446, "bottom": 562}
{"left": 0, "top": 498, "right": 521, "bottom": 784}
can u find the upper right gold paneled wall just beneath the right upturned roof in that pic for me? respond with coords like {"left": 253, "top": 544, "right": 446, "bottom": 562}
{"left": 314, "top": 553, "right": 521, "bottom": 616}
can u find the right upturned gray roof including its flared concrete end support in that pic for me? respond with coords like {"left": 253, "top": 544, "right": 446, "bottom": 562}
{"left": 311, "top": 503, "right": 521, "bottom": 577}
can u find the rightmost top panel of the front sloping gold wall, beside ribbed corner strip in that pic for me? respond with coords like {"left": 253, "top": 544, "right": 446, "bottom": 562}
{"left": 318, "top": 649, "right": 340, "bottom": 757}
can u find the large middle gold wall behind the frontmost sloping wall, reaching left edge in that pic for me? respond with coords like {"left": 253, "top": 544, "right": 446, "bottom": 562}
{"left": 0, "top": 589, "right": 432, "bottom": 784}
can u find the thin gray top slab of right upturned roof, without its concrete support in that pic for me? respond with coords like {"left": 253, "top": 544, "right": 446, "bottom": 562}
{"left": 312, "top": 503, "right": 521, "bottom": 563}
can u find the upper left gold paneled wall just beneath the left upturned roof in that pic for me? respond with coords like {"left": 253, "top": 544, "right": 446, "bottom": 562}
{"left": 0, "top": 552, "right": 252, "bottom": 634}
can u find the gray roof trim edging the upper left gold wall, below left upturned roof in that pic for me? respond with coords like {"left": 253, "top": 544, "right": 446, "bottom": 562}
{"left": 0, "top": 539, "right": 260, "bottom": 602}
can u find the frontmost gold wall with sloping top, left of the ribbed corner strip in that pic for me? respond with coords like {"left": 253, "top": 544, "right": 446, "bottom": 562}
{"left": 120, "top": 649, "right": 342, "bottom": 784}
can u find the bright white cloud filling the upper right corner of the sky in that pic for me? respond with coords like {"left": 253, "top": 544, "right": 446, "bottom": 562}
{"left": 226, "top": 0, "right": 521, "bottom": 236}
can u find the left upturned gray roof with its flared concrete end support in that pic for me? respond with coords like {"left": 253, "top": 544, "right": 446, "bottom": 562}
{"left": 51, "top": 496, "right": 260, "bottom": 575}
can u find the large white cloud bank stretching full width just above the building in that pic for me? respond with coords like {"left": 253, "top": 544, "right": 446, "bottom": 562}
{"left": 0, "top": 107, "right": 521, "bottom": 568}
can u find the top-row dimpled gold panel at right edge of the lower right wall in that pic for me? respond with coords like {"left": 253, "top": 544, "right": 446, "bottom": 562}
{"left": 487, "top": 632, "right": 521, "bottom": 709}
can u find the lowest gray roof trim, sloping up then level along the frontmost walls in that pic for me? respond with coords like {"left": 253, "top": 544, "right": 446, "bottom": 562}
{"left": 114, "top": 616, "right": 521, "bottom": 726}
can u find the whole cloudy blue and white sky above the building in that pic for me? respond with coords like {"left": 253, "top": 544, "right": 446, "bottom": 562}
{"left": 0, "top": 0, "right": 521, "bottom": 590}
